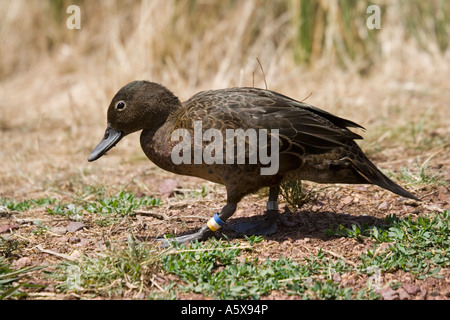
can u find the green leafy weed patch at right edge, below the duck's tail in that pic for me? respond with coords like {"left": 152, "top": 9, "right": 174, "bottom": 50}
{"left": 327, "top": 210, "right": 450, "bottom": 279}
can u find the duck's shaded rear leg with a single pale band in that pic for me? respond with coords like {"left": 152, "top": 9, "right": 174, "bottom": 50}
{"left": 229, "top": 185, "right": 280, "bottom": 235}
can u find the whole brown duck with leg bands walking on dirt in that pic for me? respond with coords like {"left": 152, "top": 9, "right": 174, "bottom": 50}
{"left": 88, "top": 81, "right": 419, "bottom": 243}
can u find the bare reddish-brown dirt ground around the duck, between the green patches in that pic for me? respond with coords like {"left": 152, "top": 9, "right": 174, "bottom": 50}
{"left": 0, "top": 146, "right": 450, "bottom": 300}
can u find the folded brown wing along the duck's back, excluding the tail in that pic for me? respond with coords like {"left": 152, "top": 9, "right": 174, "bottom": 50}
{"left": 177, "top": 88, "right": 362, "bottom": 154}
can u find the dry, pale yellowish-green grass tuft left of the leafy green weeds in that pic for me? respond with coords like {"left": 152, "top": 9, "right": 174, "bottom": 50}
{"left": 48, "top": 235, "right": 162, "bottom": 297}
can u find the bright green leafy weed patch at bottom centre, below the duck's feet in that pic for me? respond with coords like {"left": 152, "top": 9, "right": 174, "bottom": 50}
{"left": 163, "top": 240, "right": 377, "bottom": 299}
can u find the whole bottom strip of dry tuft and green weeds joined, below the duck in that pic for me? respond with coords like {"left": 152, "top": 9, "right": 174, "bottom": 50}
{"left": 49, "top": 237, "right": 378, "bottom": 299}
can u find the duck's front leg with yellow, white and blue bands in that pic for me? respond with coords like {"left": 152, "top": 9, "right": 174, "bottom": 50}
{"left": 157, "top": 202, "right": 237, "bottom": 247}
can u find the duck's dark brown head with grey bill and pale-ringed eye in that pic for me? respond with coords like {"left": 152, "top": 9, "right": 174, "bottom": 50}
{"left": 88, "top": 81, "right": 181, "bottom": 162}
